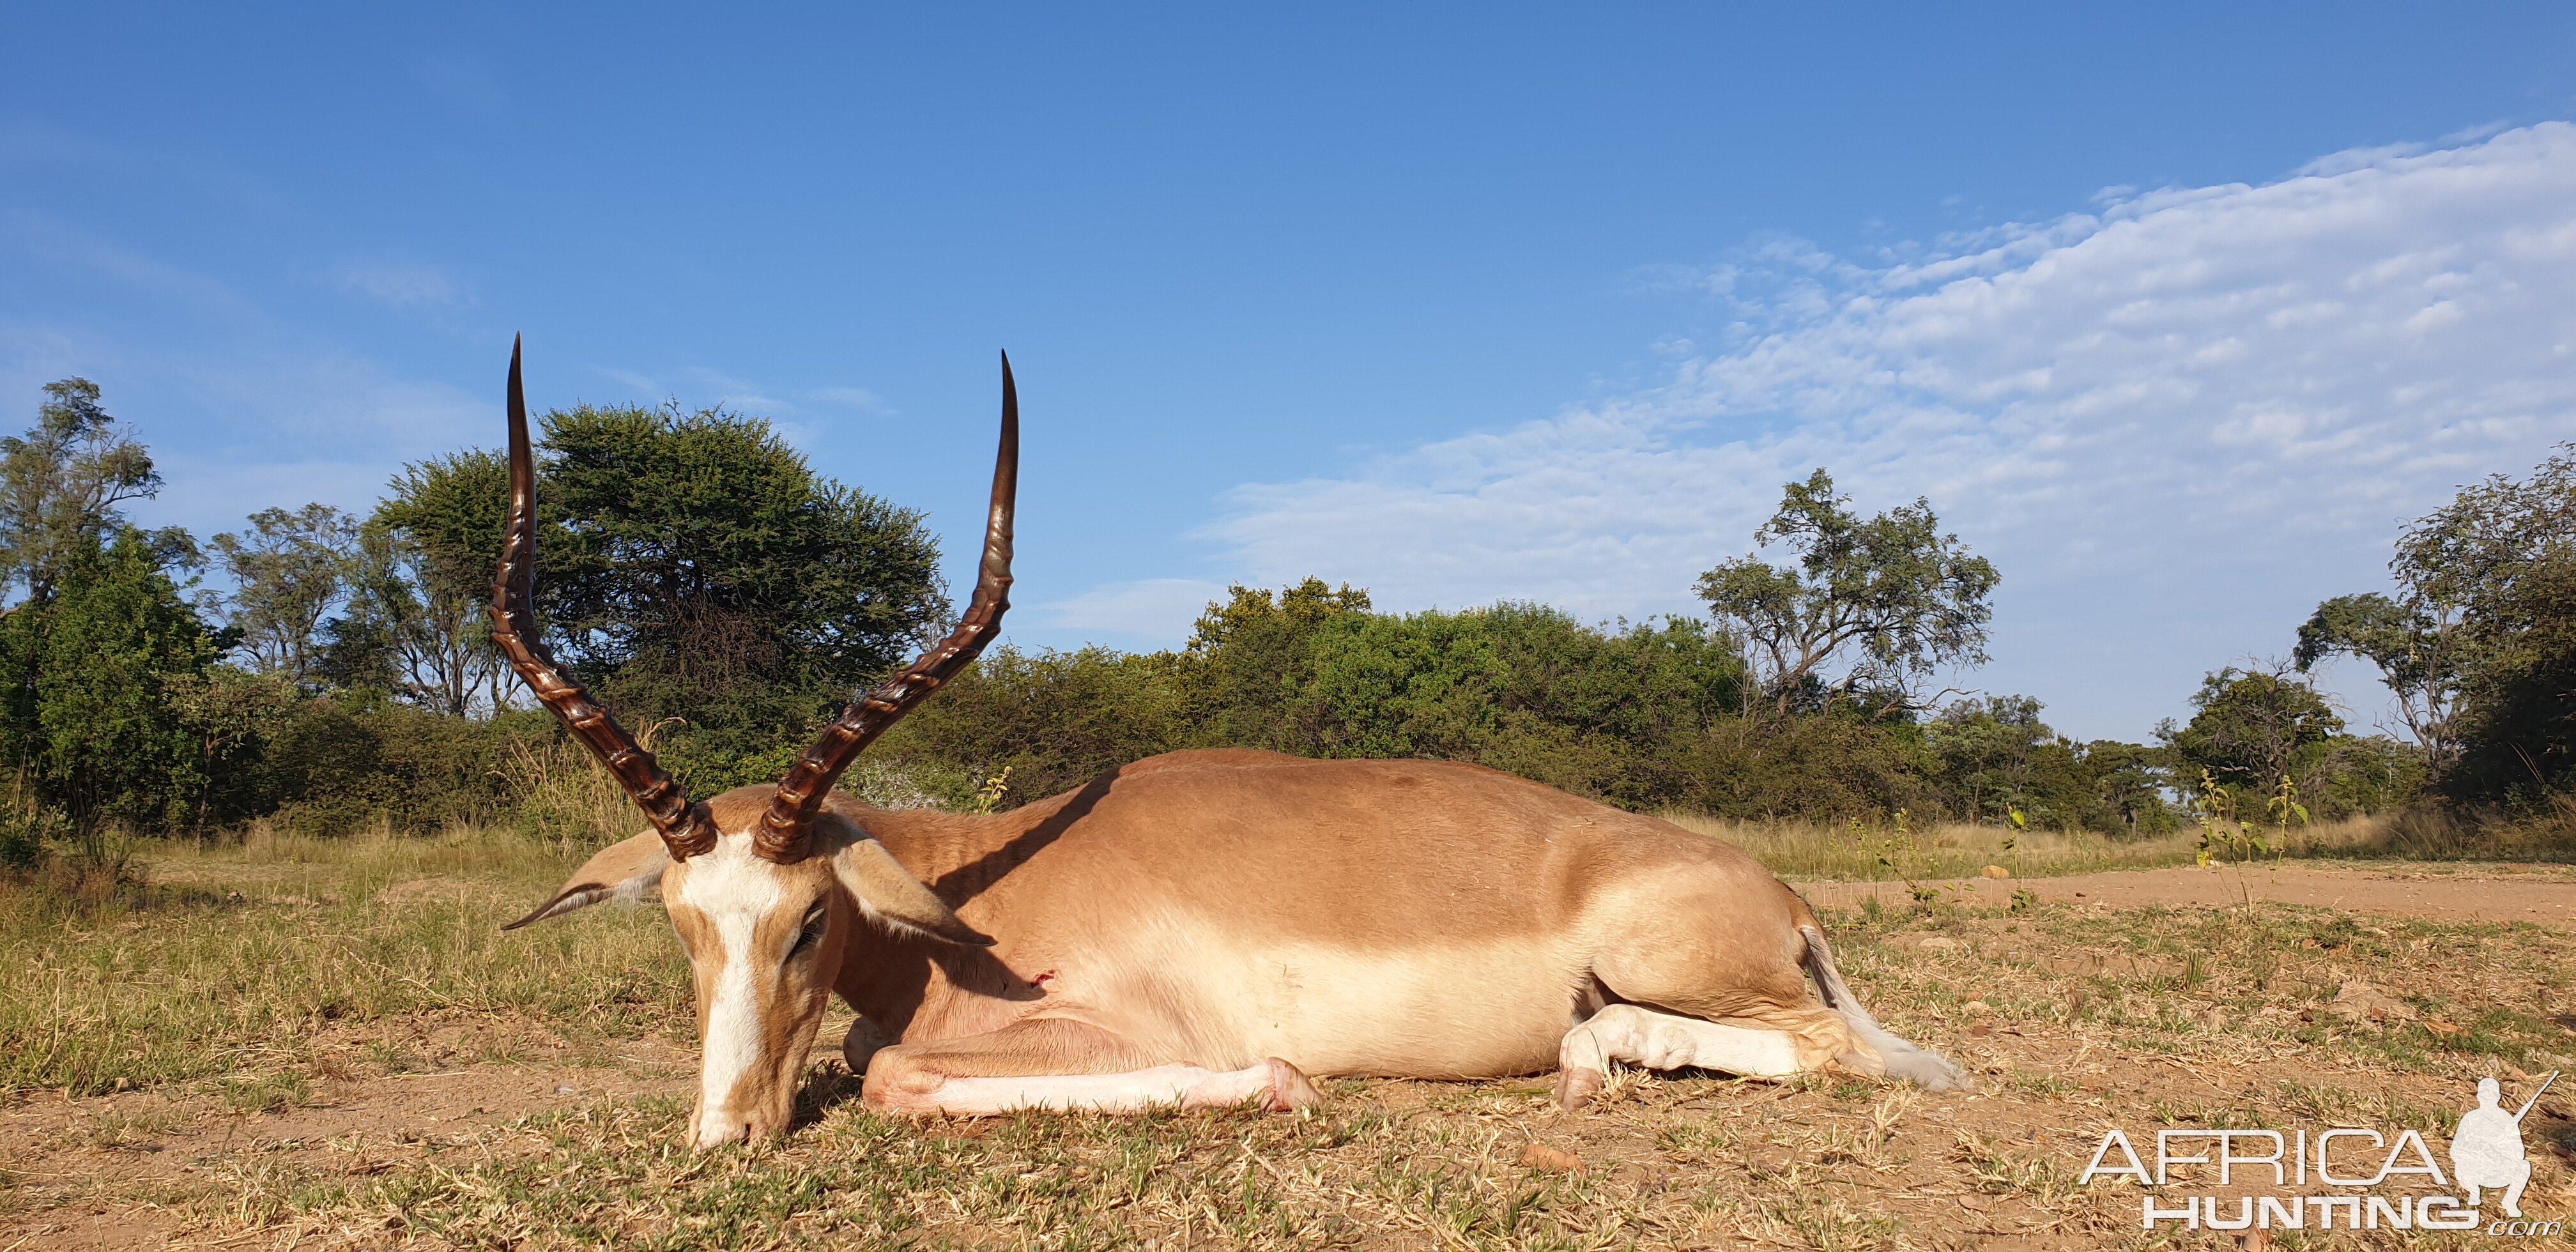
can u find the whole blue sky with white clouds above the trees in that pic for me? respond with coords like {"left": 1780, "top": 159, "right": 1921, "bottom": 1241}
{"left": 0, "top": 5, "right": 2576, "bottom": 737}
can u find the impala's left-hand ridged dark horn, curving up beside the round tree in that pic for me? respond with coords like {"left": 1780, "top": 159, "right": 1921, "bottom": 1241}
{"left": 492, "top": 337, "right": 716, "bottom": 860}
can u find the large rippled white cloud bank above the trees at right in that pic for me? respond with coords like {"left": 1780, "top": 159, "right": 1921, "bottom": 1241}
{"left": 1206, "top": 124, "right": 2576, "bottom": 734}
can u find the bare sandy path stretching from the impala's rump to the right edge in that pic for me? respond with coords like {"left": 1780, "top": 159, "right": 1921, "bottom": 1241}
{"left": 1793, "top": 863, "right": 2576, "bottom": 930}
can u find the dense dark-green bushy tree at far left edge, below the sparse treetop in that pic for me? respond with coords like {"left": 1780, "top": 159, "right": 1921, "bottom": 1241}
{"left": 0, "top": 528, "right": 217, "bottom": 837}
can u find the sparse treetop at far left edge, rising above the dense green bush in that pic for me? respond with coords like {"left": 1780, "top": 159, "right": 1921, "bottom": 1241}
{"left": 0, "top": 379, "right": 175, "bottom": 603}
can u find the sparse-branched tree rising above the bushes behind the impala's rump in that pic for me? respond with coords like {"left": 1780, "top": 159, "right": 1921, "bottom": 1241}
{"left": 1700, "top": 469, "right": 2002, "bottom": 714}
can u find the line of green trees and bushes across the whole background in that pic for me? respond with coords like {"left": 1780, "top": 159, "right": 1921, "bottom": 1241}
{"left": 0, "top": 379, "right": 2545, "bottom": 860}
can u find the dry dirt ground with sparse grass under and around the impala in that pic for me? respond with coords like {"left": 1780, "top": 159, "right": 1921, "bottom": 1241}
{"left": 0, "top": 866, "right": 2576, "bottom": 1252}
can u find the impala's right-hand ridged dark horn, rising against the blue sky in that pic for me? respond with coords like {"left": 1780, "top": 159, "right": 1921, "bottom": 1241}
{"left": 752, "top": 353, "right": 1020, "bottom": 866}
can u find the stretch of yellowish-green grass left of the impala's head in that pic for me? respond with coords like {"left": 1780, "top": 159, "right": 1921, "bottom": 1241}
{"left": 0, "top": 830, "right": 691, "bottom": 1095}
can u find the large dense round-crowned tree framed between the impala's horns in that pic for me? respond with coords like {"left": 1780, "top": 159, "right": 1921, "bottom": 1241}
{"left": 541, "top": 407, "right": 948, "bottom": 788}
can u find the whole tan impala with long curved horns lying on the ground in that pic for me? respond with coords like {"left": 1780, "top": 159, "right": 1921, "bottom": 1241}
{"left": 492, "top": 345, "right": 1958, "bottom": 1147}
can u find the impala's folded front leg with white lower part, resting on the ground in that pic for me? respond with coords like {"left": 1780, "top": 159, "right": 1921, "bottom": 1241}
{"left": 863, "top": 1018, "right": 1321, "bottom": 1118}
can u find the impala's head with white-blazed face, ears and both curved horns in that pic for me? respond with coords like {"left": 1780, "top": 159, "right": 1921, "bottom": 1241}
{"left": 492, "top": 345, "right": 1020, "bottom": 1147}
